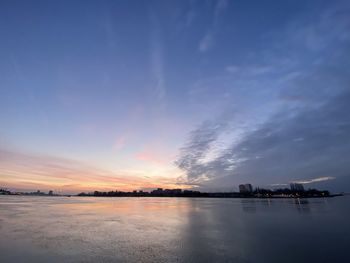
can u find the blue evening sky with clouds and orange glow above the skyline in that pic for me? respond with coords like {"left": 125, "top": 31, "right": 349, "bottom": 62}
{"left": 0, "top": 0, "right": 350, "bottom": 193}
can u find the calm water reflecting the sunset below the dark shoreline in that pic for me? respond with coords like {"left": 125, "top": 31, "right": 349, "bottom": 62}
{"left": 0, "top": 196, "right": 350, "bottom": 263}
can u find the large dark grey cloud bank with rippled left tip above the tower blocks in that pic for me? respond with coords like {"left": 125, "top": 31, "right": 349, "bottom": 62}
{"left": 176, "top": 87, "right": 350, "bottom": 192}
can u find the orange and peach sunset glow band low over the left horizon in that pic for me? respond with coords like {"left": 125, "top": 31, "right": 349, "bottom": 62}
{"left": 0, "top": 148, "right": 191, "bottom": 193}
